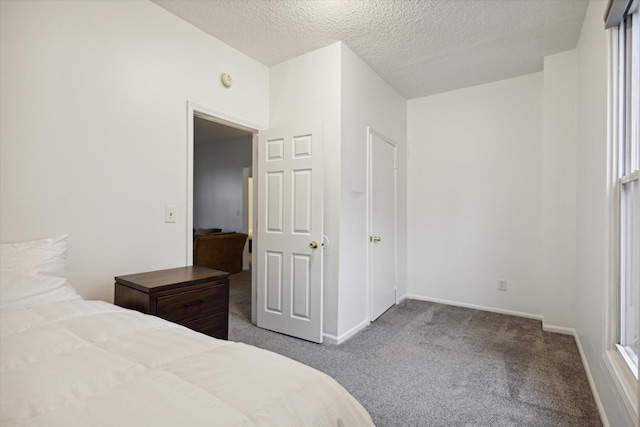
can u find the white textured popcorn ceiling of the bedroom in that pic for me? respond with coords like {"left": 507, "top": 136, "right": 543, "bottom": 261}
{"left": 152, "top": 0, "right": 588, "bottom": 99}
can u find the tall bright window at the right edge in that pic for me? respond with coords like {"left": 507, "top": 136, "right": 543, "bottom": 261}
{"left": 610, "top": 0, "right": 640, "bottom": 378}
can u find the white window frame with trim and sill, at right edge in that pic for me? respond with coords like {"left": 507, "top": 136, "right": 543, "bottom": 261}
{"left": 603, "top": 0, "right": 640, "bottom": 426}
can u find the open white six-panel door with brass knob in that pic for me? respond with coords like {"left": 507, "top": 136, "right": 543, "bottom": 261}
{"left": 254, "top": 126, "right": 324, "bottom": 343}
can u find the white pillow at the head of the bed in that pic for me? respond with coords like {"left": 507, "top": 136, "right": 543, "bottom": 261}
{"left": 0, "top": 235, "right": 81, "bottom": 311}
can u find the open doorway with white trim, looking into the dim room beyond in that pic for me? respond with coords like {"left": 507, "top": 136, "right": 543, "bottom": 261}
{"left": 187, "top": 103, "right": 257, "bottom": 322}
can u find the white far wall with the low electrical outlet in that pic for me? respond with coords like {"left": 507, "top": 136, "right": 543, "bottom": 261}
{"left": 407, "top": 73, "right": 543, "bottom": 315}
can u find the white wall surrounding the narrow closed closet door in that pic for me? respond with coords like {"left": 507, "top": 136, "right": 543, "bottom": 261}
{"left": 337, "top": 45, "right": 407, "bottom": 339}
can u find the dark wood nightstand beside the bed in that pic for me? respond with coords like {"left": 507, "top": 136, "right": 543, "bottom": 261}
{"left": 114, "top": 266, "right": 229, "bottom": 340}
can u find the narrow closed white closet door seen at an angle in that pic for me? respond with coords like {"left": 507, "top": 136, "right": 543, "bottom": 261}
{"left": 369, "top": 130, "right": 397, "bottom": 321}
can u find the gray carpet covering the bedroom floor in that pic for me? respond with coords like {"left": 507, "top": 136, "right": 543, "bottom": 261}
{"left": 229, "top": 271, "right": 602, "bottom": 427}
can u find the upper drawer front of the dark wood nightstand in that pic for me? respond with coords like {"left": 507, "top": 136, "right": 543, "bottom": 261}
{"left": 156, "top": 284, "right": 228, "bottom": 321}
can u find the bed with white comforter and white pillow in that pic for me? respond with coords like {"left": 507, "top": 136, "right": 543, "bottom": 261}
{"left": 0, "top": 236, "right": 373, "bottom": 426}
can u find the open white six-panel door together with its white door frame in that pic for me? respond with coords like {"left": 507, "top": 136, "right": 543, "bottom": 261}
{"left": 186, "top": 102, "right": 324, "bottom": 342}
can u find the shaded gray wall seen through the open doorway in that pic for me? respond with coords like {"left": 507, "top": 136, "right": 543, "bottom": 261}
{"left": 193, "top": 136, "right": 253, "bottom": 233}
